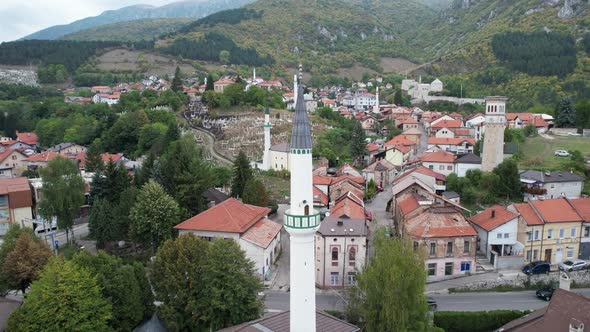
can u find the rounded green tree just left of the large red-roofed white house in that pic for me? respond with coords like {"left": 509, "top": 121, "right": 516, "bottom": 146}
{"left": 130, "top": 180, "right": 180, "bottom": 250}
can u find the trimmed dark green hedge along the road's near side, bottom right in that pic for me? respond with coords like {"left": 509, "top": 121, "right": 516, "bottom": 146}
{"left": 434, "top": 310, "right": 530, "bottom": 332}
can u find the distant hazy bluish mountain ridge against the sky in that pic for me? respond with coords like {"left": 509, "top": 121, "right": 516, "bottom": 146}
{"left": 23, "top": 0, "right": 254, "bottom": 39}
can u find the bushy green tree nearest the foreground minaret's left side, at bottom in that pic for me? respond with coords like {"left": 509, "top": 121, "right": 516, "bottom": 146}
{"left": 203, "top": 239, "right": 264, "bottom": 331}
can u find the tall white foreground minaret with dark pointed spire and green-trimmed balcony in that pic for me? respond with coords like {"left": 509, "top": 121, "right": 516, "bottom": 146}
{"left": 285, "top": 83, "right": 320, "bottom": 332}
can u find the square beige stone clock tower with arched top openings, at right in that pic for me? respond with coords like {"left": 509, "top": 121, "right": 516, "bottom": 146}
{"left": 481, "top": 96, "right": 508, "bottom": 172}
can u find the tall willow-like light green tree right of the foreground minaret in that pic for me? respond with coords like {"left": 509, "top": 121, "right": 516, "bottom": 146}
{"left": 347, "top": 231, "right": 430, "bottom": 332}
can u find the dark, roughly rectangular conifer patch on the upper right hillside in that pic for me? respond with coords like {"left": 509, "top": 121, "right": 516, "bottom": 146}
{"left": 492, "top": 32, "right": 577, "bottom": 77}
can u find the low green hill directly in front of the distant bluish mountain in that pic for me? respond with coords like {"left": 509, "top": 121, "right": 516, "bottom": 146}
{"left": 59, "top": 18, "right": 195, "bottom": 41}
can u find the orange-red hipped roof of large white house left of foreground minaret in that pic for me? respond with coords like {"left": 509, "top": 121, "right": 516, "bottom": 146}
{"left": 174, "top": 197, "right": 270, "bottom": 233}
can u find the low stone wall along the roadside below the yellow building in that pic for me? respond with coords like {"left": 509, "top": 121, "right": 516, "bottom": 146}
{"left": 457, "top": 270, "right": 590, "bottom": 291}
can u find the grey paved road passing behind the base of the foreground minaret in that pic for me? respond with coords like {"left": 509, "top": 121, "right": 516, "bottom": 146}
{"left": 265, "top": 288, "right": 590, "bottom": 311}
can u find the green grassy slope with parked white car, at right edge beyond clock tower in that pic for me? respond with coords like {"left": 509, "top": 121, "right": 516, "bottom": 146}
{"left": 519, "top": 136, "right": 590, "bottom": 171}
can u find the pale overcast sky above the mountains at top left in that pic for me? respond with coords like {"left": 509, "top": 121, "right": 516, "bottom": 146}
{"left": 0, "top": 0, "right": 174, "bottom": 42}
